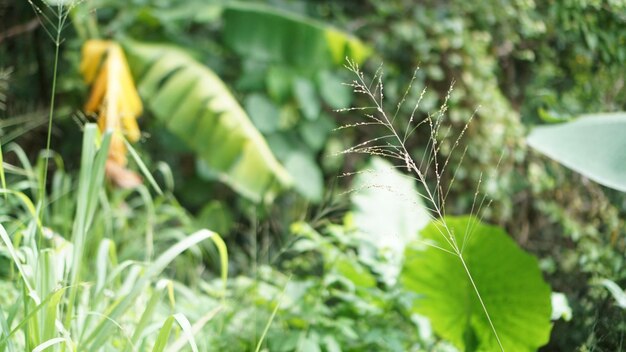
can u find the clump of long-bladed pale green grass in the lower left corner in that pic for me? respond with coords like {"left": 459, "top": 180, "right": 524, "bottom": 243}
{"left": 0, "top": 124, "right": 228, "bottom": 351}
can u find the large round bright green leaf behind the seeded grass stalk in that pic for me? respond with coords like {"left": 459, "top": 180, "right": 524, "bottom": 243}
{"left": 401, "top": 216, "right": 551, "bottom": 351}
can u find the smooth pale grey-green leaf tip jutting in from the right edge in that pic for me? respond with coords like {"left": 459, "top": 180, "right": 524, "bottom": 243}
{"left": 528, "top": 112, "right": 626, "bottom": 192}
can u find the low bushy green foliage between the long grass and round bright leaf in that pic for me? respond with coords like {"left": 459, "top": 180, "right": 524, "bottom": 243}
{"left": 211, "top": 223, "right": 424, "bottom": 351}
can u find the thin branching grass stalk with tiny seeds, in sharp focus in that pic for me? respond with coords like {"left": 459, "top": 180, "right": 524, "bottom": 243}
{"left": 338, "top": 59, "right": 504, "bottom": 351}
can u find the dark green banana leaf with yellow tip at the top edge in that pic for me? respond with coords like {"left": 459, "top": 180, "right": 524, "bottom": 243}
{"left": 222, "top": 3, "right": 371, "bottom": 70}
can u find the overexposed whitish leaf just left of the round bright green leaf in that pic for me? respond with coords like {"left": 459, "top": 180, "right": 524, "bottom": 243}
{"left": 352, "top": 157, "right": 430, "bottom": 284}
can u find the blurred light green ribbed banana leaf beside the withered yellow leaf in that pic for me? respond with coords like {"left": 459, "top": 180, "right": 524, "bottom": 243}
{"left": 125, "top": 41, "right": 291, "bottom": 202}
